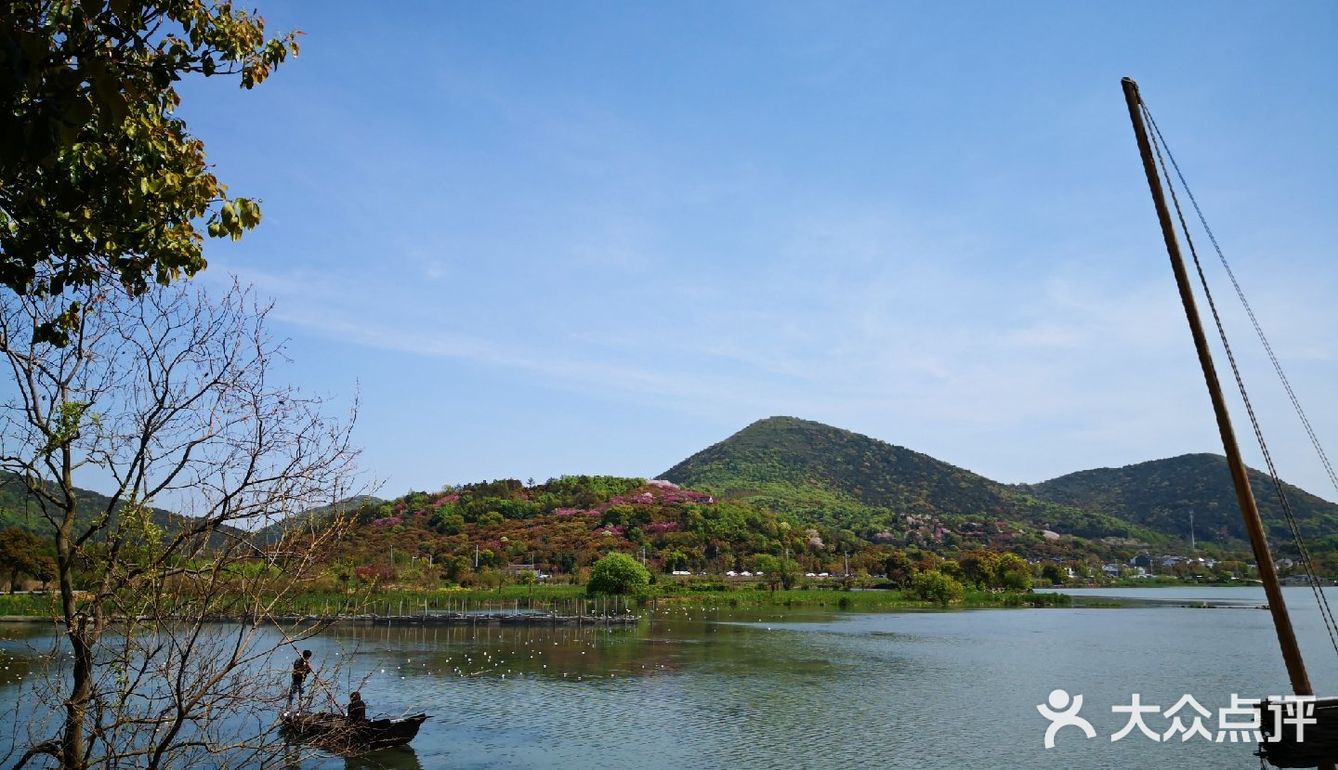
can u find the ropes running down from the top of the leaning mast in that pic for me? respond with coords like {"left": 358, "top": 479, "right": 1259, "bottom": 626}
{"left": 1140, "top": 99, "right": 1338, "bottom": 666}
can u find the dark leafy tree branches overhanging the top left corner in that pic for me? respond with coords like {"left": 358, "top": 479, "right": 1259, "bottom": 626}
{"left": 0, "top": 0, "right": 297, "bottom": 345}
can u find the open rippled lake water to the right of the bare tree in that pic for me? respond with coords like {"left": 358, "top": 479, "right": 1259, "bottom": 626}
{"left": 0, "top": 588, "right": 1338, "bottom": 770}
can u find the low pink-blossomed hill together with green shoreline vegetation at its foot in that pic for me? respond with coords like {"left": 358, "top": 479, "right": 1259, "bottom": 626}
{"left": 0, "top": 477, "right": 1263, "bottom": 616}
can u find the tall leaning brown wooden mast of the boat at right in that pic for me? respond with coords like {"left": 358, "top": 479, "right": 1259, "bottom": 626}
{"left": 1121, "top": 78, "right": 1314, "bottom": 695}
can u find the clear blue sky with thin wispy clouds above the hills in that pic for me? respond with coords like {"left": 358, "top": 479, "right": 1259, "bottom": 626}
{"left": 172, "top": 0, "right": 1338, "bottom": 498}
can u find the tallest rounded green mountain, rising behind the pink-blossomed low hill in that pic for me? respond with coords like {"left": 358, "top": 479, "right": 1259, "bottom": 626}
{"left": 664, "top": 416, "right": 1163, "bottom": 549}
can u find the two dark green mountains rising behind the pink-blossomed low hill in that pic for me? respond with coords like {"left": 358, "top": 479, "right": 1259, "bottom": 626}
{"left": 662, "top": 416, "right": 1338, "bottom": 546}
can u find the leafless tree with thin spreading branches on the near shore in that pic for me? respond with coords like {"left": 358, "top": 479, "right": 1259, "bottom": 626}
{"left": 0, "top": 284, "right": 359, "bottom": 770}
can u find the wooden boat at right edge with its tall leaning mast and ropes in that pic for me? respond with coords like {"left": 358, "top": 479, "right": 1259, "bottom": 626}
{"left": 1121, "top": 78, "right": 1338, "bottom": 770}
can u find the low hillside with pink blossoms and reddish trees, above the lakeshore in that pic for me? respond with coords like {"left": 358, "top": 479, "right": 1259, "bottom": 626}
{"left": 310, "top": 475, "right": 1129, "bottom": 583}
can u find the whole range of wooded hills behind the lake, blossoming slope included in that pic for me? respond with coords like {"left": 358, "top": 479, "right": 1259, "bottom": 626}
{"left": 10, "top": 418, "right": 1338, "bottom": 584}
